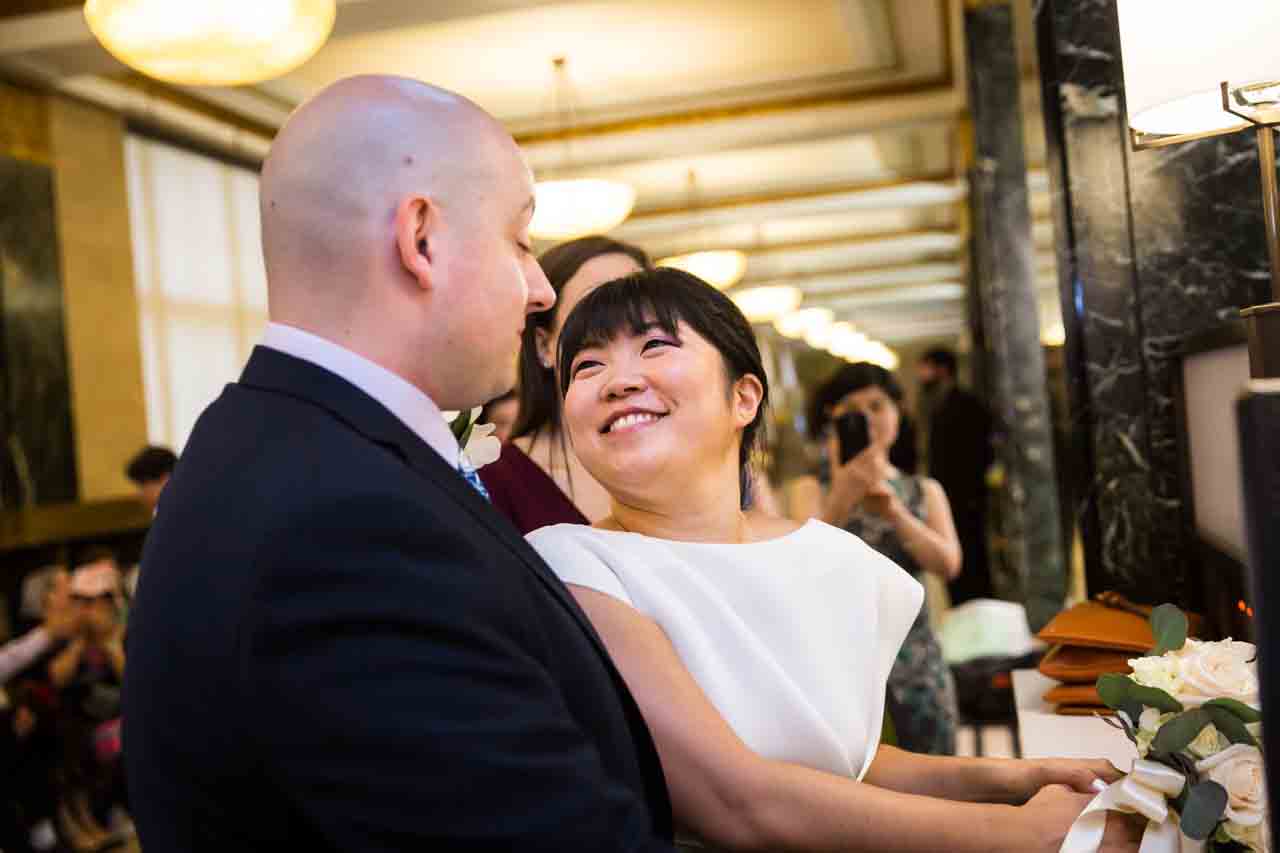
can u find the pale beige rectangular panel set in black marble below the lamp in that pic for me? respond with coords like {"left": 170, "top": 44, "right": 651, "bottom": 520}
{"left": 1183, "top": 343, "right": 1249, "bottom": 558}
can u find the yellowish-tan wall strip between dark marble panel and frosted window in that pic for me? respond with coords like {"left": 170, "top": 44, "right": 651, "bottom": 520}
{"left": 47, "top": 96, "right": 147, "bottom": 501}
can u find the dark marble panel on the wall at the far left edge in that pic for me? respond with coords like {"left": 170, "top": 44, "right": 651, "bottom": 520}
{"left": 0, "top": 156, "right": 77, "bottom": 507}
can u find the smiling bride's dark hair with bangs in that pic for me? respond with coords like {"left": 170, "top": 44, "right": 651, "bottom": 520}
{"left": 557, "top": 266, "right": 769, "bottom": 508}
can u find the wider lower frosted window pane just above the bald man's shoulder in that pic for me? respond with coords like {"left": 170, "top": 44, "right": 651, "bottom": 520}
{"left": 164, "top": 315, "right": 241, "bottom": 452}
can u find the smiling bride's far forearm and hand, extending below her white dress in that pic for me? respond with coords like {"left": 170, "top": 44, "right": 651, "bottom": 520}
{"left": 864, "top": 747, "right": 1124, "bottom": 804}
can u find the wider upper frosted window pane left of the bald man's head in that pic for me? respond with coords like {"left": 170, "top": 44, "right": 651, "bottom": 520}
{"left": 148, "top": 142, "right": 236, "bottom": 305}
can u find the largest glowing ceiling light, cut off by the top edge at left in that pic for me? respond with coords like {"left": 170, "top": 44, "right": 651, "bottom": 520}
{"left": 84, "top": 0, "right": 335, "bottom": 86}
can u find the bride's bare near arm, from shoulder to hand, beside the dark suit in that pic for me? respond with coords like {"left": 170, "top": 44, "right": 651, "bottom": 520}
{"left": 570, "top": 584, "right": 1137, "bottom": 853}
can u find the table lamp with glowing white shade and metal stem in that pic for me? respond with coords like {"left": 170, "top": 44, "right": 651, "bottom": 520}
{"left": 1116, "top": 0, "right": 1280, "bottom": 379}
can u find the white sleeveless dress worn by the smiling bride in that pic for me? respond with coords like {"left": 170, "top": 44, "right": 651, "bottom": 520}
{"left": 529, "top": 520, "right": 924, "bottom": 814}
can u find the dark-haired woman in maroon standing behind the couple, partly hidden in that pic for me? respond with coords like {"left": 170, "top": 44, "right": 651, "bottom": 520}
{"left": 480, "top": 236, "right": 650, "bottom": 533}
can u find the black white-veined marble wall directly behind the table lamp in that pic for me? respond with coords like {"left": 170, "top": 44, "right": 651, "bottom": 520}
{"left": 1036, "top": 0, "right": 1268, "bottom": 605}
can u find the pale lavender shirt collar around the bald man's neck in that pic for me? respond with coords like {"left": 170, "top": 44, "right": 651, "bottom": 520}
{"left": 262, "top": 323, "right": 458, "bottom": 467}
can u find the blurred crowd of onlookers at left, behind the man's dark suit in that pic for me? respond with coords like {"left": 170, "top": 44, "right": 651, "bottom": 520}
{"left": 0, "top": 447, "right": 177, "bottom": 853}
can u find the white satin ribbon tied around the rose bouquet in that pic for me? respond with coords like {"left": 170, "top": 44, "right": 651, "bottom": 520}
{"left": 1059, "top": 758, "right": 1204, "bottom": 853}
